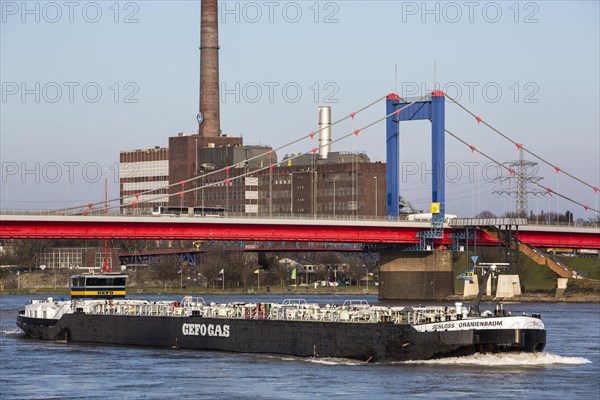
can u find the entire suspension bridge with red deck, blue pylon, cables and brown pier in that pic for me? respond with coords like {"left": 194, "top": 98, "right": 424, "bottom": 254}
{"left": 0, "top": 90, "right": 600, "bottom": 299}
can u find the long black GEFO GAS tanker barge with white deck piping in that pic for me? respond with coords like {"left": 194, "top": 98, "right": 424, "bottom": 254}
{"left": 17, "top": 272, "right": 546, "bottom": 362}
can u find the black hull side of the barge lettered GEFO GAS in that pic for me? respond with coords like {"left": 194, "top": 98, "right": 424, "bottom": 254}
{"left": 17, "top": 314, "right": 546, "bottom": 361}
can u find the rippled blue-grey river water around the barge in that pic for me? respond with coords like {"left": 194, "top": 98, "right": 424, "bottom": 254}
{"left": 0, "top": 294, "right": 600, "bottom": 400}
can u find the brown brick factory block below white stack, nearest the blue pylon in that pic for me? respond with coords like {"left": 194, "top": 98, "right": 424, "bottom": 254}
{"left": 259, "top": 152, "right": 386, "bottom": 218}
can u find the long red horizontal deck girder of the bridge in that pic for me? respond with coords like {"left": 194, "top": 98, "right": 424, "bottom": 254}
{"left": 0, "top": 214, "right": 600, "bottom": 249}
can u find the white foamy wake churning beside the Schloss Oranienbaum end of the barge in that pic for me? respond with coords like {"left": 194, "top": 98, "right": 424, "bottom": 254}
{"left": 403, "top": 353, "right": 591, "bottom": 367}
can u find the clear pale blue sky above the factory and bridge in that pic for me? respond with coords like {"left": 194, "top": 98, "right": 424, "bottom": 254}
{"left": 0, "top": 1, "right": 600, "bottom": 217}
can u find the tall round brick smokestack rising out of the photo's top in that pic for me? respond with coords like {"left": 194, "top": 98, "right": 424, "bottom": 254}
{"left": 198, "top": 0, "right": 221, "bottom": 137}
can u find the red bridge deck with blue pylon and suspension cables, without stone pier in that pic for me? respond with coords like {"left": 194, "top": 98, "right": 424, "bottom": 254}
{"left": 0, "top": 90, "right": 600, "bottom": 250}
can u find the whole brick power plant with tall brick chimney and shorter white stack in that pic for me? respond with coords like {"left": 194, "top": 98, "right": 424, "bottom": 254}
{"left": 119, "top": 1, "right": 386, "bottom": 218}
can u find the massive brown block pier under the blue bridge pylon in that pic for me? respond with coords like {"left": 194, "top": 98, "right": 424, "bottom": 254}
{"left": 379, "top": 250, "right": 454, "bottom": 300}
